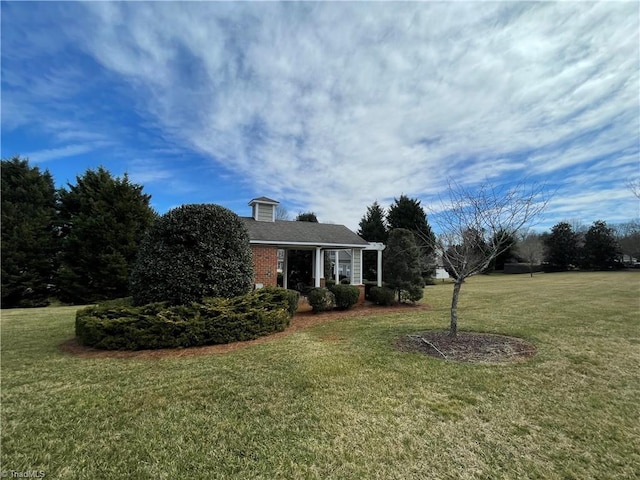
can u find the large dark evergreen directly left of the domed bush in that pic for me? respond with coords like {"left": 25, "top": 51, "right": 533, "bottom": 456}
{"left": 58, "top": 167, "right": 156, "bottom": 303}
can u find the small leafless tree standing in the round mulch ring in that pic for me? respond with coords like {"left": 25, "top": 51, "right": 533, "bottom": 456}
{"left": 425, "top": 181, "right": 548, "bottom": 337}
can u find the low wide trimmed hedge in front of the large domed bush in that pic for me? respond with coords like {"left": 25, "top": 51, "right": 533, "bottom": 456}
{"left": 76, "top": 288, "right": 298, "bottom": 350}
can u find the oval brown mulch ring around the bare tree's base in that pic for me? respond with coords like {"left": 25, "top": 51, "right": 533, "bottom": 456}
{"left": 396, "top": 331, "right": 536, "bottom": 363}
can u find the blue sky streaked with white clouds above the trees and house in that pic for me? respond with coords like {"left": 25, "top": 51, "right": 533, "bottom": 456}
{"left": 1, "top": 1, "right": 640, "bottom": 229}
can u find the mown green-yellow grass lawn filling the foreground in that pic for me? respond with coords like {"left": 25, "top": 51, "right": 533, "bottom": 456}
{"left": 0, "top": 272, "right": 640, "bottom": 480}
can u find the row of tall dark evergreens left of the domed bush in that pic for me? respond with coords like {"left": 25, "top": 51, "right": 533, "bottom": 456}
{"left": 1, "top": 156, "right": 156, "bottom": 308}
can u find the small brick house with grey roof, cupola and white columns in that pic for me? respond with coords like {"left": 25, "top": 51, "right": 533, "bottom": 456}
{"left": 241, "top": 197, "right": 385, "bottom": 299}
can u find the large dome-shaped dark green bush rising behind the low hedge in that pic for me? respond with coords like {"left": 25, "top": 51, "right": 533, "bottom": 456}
{"left": 131, "top": 204, "right": 253, "bottom": 305}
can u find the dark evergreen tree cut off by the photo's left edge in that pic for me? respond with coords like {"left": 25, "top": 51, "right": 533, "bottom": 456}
{"left": 1, "top": 157, "right": 57, "bottom": 308}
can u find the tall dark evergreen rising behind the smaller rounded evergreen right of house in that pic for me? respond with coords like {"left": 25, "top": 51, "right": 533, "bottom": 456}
{"left": 387, "top": 195, "right": 436, "bottom": 278}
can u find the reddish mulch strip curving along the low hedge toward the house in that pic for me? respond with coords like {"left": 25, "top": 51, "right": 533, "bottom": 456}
{"left": 60, "top": 302, "right": 430, "bottom": 359}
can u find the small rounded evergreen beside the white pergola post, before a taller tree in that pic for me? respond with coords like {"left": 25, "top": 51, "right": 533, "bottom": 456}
{"left": 382, "top": 228, "right": 424, "bottom": 301}
